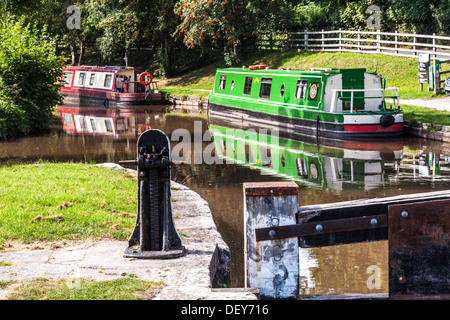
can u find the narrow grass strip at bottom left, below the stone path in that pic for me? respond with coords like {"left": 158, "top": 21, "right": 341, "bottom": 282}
{"left": 6, "top": 278, "right": 164, "bottom": 300}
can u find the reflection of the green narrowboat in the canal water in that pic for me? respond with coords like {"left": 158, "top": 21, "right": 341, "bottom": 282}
{"left": 209, "top": 124, "right": 403, "bottom": 190}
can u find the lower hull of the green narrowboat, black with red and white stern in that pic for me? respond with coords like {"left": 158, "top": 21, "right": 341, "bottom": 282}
{"left": 208, "top": 102, "right": 403, "bottom": 140}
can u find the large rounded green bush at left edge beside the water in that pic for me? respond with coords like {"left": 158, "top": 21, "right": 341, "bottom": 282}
{"left": 0, "top": 17, "right": 63, "bottom": 138}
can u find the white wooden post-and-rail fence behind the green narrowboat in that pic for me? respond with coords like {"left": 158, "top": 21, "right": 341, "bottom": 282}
{"left": 256, "top": 29, "right": 450, "bottom": 59}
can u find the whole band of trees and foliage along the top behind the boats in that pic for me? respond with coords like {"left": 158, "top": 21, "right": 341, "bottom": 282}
{"left": 0, "top": 0, "right": 450, "bottom": 76}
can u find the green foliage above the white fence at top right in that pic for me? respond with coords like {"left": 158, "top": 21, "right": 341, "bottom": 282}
{"left": 291, "top": 0, "right": 450, "bottom": 35}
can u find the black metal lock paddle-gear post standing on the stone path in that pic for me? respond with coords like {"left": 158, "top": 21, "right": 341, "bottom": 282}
{"left": 119, "top": 129, "right": 185, "bottom": 259}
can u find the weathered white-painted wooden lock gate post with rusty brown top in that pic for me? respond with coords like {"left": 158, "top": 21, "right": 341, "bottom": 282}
{"left": 243, "top": 181, "right": 299, "bottom": 299}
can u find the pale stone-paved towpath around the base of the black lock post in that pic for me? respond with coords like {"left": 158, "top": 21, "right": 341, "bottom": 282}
{"left": 0, "top": 164, "right": 257, "bottom": 300}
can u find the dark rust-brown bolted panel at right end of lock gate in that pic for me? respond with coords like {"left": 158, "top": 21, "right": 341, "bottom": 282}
{"left": 389, "top": 200, "right": 450, "bottom": 299}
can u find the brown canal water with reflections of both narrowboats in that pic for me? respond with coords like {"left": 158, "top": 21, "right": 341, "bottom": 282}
{"left": 0, "top": 106, "right": 450, "bottom": 295}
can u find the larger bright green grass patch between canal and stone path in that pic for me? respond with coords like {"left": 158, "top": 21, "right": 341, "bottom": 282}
{"left": 0, "top": 163, "right": 137, "bottom": 246}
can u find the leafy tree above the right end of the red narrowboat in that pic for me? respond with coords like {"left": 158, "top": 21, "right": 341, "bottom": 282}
{"left": 82, "top": 0, "right": 183, "bottom": 64}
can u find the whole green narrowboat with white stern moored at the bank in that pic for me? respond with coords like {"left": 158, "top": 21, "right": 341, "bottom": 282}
{"left": 208, "top": 65, "right": 403, "bottom": 140}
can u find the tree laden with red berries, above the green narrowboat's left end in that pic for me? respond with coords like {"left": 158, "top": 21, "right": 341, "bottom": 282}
{"left": 175, "top": 0, "right": 292, "bottom": 64}
